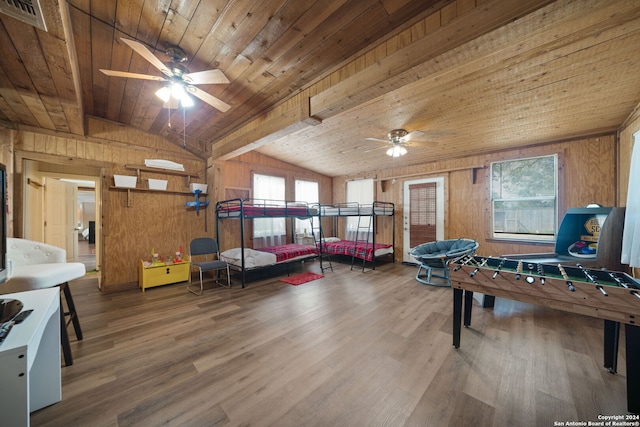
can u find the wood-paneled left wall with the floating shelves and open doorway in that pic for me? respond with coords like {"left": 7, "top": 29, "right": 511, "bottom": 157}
{"left": 9, "top": 119, "right": 212, "bottom": 290}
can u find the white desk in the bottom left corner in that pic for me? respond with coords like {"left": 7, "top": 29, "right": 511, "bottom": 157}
{"left": 0, "top": 285, "right": 62, "bottom": 426}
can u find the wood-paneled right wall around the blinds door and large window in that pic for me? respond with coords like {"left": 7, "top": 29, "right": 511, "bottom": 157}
{"left": 333, "top": 135, "right": 617, "bottom": 261}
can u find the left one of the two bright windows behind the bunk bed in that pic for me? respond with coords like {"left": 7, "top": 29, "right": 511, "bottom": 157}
{"left": 253, "top": 173, "right": 287, "bottom": 248}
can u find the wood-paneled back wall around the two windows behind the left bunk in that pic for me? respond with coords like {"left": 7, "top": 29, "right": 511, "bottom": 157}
{"left": 211, "top": 152, "right": 332, "bottom": 250}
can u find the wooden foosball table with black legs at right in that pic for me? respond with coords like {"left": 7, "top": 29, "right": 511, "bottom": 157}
{"left": 449, "top": 256, "right": 640, "bottom": 413}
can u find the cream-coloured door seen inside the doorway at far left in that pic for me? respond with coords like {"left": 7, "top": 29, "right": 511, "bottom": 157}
{"left": 44, "top": 178, "right": 78, "bottom": 259}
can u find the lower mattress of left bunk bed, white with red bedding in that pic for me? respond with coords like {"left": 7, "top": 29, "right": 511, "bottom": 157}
{"left": 220, "top": 244, "right": 318, "bottom": 269}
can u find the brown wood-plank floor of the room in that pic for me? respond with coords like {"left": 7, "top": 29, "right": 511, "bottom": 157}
{"left": 31, "top": 263, "right": 627, "bottom": 427}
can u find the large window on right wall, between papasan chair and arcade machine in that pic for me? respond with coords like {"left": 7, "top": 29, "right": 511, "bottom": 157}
{"left": 491, "top": 155, "right": 558, "bottom": 241}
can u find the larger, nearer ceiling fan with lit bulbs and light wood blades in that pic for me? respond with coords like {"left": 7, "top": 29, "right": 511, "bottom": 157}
{"left": 100, "top": 38, "right": 231, "bottom": 112}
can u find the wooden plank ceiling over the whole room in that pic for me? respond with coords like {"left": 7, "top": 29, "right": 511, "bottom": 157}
{"left": 0, "top": 0, "right": 640, "bottom": 176}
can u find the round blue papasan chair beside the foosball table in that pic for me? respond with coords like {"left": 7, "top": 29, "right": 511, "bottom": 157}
{"left": 411, "top": 239, "right": 479, "bottom": 286}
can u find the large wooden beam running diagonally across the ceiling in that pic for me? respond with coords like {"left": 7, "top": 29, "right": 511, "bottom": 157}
{"left": 212, "top": 0, "right": 552, "bottom": 160}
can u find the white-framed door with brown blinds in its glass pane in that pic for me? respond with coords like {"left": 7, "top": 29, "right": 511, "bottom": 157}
{"left": 402, "top": 177, "right": 444, "bottom": 263}
